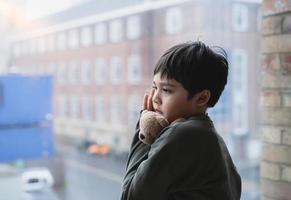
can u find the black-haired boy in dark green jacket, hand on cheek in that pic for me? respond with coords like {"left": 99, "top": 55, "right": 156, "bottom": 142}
{"left": 121, "top": 42, "right": 241, "bottom": 200}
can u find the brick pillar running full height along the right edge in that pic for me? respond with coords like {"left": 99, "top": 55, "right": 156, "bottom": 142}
{"left": 260, "top": 0, "right": 291, "bottom": 200}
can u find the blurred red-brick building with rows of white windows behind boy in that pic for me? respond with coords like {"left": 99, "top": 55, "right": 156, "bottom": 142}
{"left": 10, "top": 0, "right": 260, "bottom": 157}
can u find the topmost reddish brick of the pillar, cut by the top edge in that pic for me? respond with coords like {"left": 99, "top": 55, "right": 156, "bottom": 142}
{"left": 262, "top": 0, "right": 291, "bottom": 16}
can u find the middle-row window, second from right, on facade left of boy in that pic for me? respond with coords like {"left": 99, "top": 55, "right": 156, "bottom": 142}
{"left": 110, "top": 56, "right": 123, "bottom": 85}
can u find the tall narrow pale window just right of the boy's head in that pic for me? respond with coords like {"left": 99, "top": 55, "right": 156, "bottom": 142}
{"left": 231, "top": 49, "right": 248, "bottom": 135}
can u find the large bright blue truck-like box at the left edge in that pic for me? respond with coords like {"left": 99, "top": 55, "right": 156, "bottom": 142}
{"left": 0, "top": 74, "right": 54, "bottom": 162}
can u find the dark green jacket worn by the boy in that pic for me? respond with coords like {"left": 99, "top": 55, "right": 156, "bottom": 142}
{"left": 121, "top": 115, "right": 241, "bottom": 200}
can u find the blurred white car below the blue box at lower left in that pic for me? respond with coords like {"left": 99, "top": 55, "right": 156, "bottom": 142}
{"left": 21, "top": 168, "right": 54, "bottom": 192}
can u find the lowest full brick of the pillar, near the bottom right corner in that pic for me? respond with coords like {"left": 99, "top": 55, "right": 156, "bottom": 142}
{"left": 261, "top": 179, "right": 291, "bottom": 200}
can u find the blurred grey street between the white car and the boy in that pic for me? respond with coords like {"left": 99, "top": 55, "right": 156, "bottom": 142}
{"left": 37, "top": 146, "right": 125, "bottom": 200}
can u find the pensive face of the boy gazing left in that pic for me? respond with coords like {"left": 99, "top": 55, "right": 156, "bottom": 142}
{"left": 152, "top": 73, "right": 201, "bottom": 123}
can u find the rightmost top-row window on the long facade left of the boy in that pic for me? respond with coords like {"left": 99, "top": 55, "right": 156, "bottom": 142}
{"left": 126, "top": 16, "right": 141, "bottom": 40}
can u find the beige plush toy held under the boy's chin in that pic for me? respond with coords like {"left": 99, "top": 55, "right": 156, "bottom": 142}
{"left": 139, "top": 110, "right": 169, "bottom": 144}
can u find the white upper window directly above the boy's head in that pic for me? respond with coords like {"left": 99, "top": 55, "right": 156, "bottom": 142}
{"left": 166, "top": 7, "right": 183, "bottom": 34}
